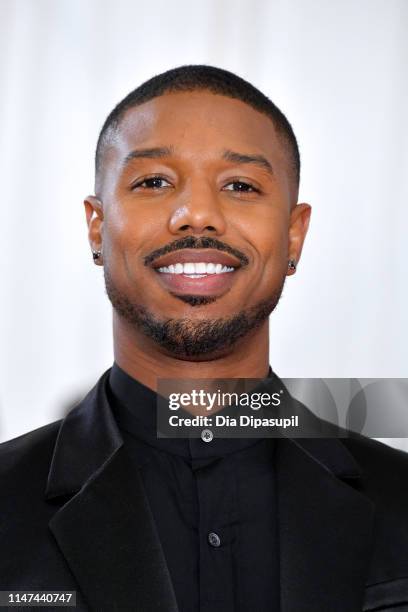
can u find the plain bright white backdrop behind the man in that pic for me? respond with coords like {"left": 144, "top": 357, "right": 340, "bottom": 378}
{"left": 0, "top": 0, "right": 408, "bottom": 448}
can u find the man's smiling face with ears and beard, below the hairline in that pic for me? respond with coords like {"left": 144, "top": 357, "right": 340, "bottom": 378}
{"left": 86, "top": 91, "right": 310, "bottom": 358}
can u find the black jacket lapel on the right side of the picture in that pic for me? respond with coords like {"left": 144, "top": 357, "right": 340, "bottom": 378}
{"left": 277, "top": 438, "right": 373, "bottom": 612}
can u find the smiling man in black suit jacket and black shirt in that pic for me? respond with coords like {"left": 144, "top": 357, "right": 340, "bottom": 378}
{"left": 0, "top": 66, "right": 408, "bottom": 612}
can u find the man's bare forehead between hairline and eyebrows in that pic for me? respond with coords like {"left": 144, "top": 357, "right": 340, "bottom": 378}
{"left": 108, "top": 91, "right": 284, "bottom": 165}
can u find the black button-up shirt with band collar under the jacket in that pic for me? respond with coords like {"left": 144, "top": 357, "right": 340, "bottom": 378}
{"left": 108, "top": 363, "right": 279, "bottom": 612}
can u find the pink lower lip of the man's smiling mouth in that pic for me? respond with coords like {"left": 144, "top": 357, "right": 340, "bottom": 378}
{"left": 156, "top": 270, "right": 237, "bottom": 296}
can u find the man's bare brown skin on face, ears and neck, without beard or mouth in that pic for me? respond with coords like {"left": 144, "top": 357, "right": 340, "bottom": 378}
{"left": 84, "top": 91, "right": 311, "bottom": 390}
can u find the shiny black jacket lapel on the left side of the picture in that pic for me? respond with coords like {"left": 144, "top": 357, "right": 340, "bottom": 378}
{"left": 47, "top": 371, "right": 177, "bottom": 612}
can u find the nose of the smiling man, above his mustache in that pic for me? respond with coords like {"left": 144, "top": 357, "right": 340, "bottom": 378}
{"left": 169, "top": 180, "right": 226, "bottom": 236}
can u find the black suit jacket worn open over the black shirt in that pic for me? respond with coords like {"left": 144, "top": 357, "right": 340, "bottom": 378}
{"left": 0, "top": 370, "right": 408, "bottom": 612}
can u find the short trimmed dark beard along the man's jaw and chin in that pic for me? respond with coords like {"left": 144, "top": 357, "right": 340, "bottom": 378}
{"left": 104, "top": 264, "right": 286, "bottom": 360}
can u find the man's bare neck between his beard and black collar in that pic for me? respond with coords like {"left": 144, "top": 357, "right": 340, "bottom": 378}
{"left": 113, "top": 311, "right": 269, "bottom": 391}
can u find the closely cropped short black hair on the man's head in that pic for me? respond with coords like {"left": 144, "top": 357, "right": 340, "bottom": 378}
{"left": 95, "top": 64, "right": 300, "bottom": 186}
